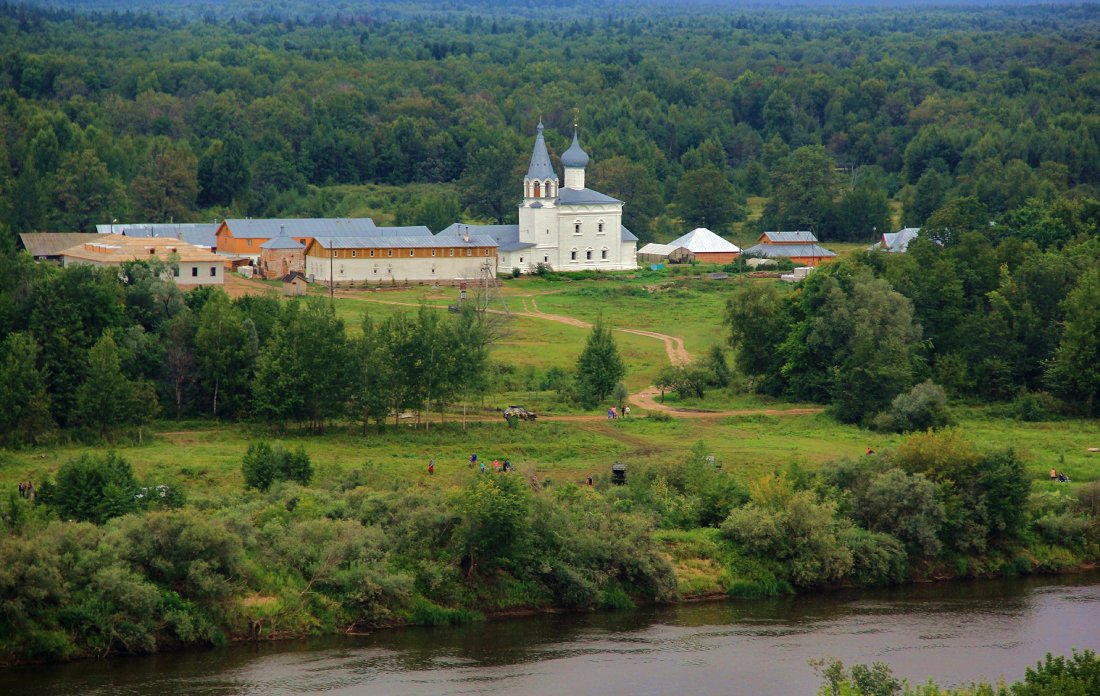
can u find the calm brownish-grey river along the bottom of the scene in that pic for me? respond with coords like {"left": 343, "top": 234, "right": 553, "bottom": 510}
{"left": 0, "top": 573, "right": 1100, "bottom": 696}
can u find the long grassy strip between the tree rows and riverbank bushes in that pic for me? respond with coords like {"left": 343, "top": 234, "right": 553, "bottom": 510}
{"left": 0, "top": 411, "right": 1100, "bottom": 499}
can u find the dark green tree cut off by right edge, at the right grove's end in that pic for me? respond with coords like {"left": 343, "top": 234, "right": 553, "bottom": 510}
{"left": 1047, "top": 267, "right": 1100, "bottom": 416}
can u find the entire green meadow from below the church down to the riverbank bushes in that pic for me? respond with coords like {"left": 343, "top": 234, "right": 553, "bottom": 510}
{"left": 0, "top": 272, "right": 1100, "bottom": 501}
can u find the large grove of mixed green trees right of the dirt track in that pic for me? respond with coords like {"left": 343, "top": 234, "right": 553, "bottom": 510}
{"left": 726, "top": 227, "right": 1100, "bottom": 424}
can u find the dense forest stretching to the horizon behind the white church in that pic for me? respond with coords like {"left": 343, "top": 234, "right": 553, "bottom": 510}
{"left": 0, "top": 3, "right": 1100, "bottom": 244}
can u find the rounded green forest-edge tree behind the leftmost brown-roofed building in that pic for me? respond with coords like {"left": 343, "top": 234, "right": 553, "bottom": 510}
{"left": 50, "top": 150, "right": 123, "bottom": 232}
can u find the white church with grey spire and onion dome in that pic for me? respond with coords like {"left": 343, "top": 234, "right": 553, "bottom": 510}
{"left": 439, "top": 120, "right": 638, "bottom": 273}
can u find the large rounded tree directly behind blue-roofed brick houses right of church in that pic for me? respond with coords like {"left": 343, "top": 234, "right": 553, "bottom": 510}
{"left": 762, "top": 145, "right": 840, "bottom": 231}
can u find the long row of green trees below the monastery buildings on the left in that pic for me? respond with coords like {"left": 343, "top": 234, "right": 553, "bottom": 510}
{"left": 0, "top": 254, "right": 499, "bottom": 446}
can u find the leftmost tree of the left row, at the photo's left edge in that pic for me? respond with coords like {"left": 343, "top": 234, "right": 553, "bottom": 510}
{"left": 0, "top": 333, "right": 56, "bottom": 444}
